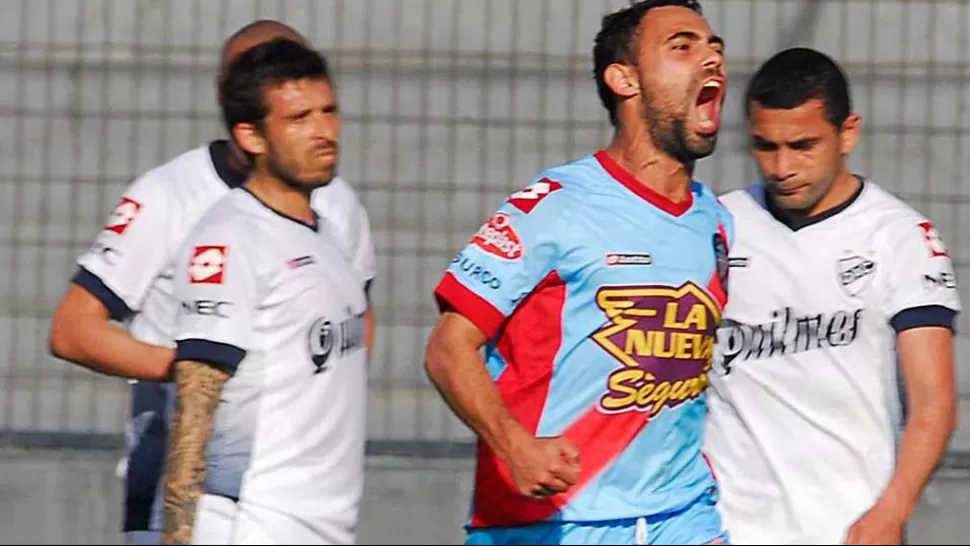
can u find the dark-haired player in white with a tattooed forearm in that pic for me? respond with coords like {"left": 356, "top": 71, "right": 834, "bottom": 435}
{"left": 164, "top": 39, "right": 367, "bottom": 544}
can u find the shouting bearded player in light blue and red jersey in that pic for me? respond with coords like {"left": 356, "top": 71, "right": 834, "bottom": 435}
{"left": 426, "top": 0, "right": 732, "bottom": 544}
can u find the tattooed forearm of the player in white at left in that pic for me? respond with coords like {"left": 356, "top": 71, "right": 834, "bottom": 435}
{"left": 163, "top": 361, "right": 229, "bottom": 544}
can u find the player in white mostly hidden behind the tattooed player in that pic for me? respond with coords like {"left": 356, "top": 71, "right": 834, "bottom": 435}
{"left": 50, "top": 20, "right": 375, "bottom": 544}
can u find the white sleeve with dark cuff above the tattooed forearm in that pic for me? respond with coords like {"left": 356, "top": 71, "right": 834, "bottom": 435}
{"left": 175, "top": 219, "right": 260, "bottom": 373}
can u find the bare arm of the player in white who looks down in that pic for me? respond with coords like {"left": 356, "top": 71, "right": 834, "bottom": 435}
{"left": 879, "top": 327, "right": 957, "bottom": 519}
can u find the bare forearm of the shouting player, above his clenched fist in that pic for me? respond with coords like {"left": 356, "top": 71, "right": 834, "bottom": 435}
{"left": 425, "top": 311, "right": 533, "bottom": 460}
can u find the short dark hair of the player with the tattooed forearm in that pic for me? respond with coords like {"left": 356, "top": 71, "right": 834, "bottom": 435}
{"left": 219, "top": 38, "right": 330, "bottom": 134}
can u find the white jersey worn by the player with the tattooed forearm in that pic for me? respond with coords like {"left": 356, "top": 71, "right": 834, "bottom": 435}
{"left": 175, "top": 188, "right": 367, "bottom": 544}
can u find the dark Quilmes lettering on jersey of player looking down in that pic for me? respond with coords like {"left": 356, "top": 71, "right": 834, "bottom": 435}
{"left": 715, "top": 307, "right": 863, "bottom": 369}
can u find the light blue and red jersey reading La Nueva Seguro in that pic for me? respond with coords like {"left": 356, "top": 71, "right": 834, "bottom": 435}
{"left": 435, "top": 151, "right": 733, "bottom": 528}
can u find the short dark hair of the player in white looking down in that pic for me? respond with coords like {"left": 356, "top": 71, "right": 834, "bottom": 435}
{"left": 744, "top": 47, "right": 852, "bottom": 129}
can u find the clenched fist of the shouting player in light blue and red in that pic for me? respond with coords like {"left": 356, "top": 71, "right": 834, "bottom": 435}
{"left": 508, "top": 436, "right": 579, "bottom": 499}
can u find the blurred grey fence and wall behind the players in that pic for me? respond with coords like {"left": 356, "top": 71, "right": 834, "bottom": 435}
{"left": 0, "top": 0, "right": 970, "bottom": 544}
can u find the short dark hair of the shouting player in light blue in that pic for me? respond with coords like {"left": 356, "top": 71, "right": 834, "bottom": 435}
{"left": 593, "top": 0, "right": 703, "bottom": 127}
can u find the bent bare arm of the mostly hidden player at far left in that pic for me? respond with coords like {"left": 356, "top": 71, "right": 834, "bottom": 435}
{"left": 48, "top": 284, "right": 175, "bottom": 381}
